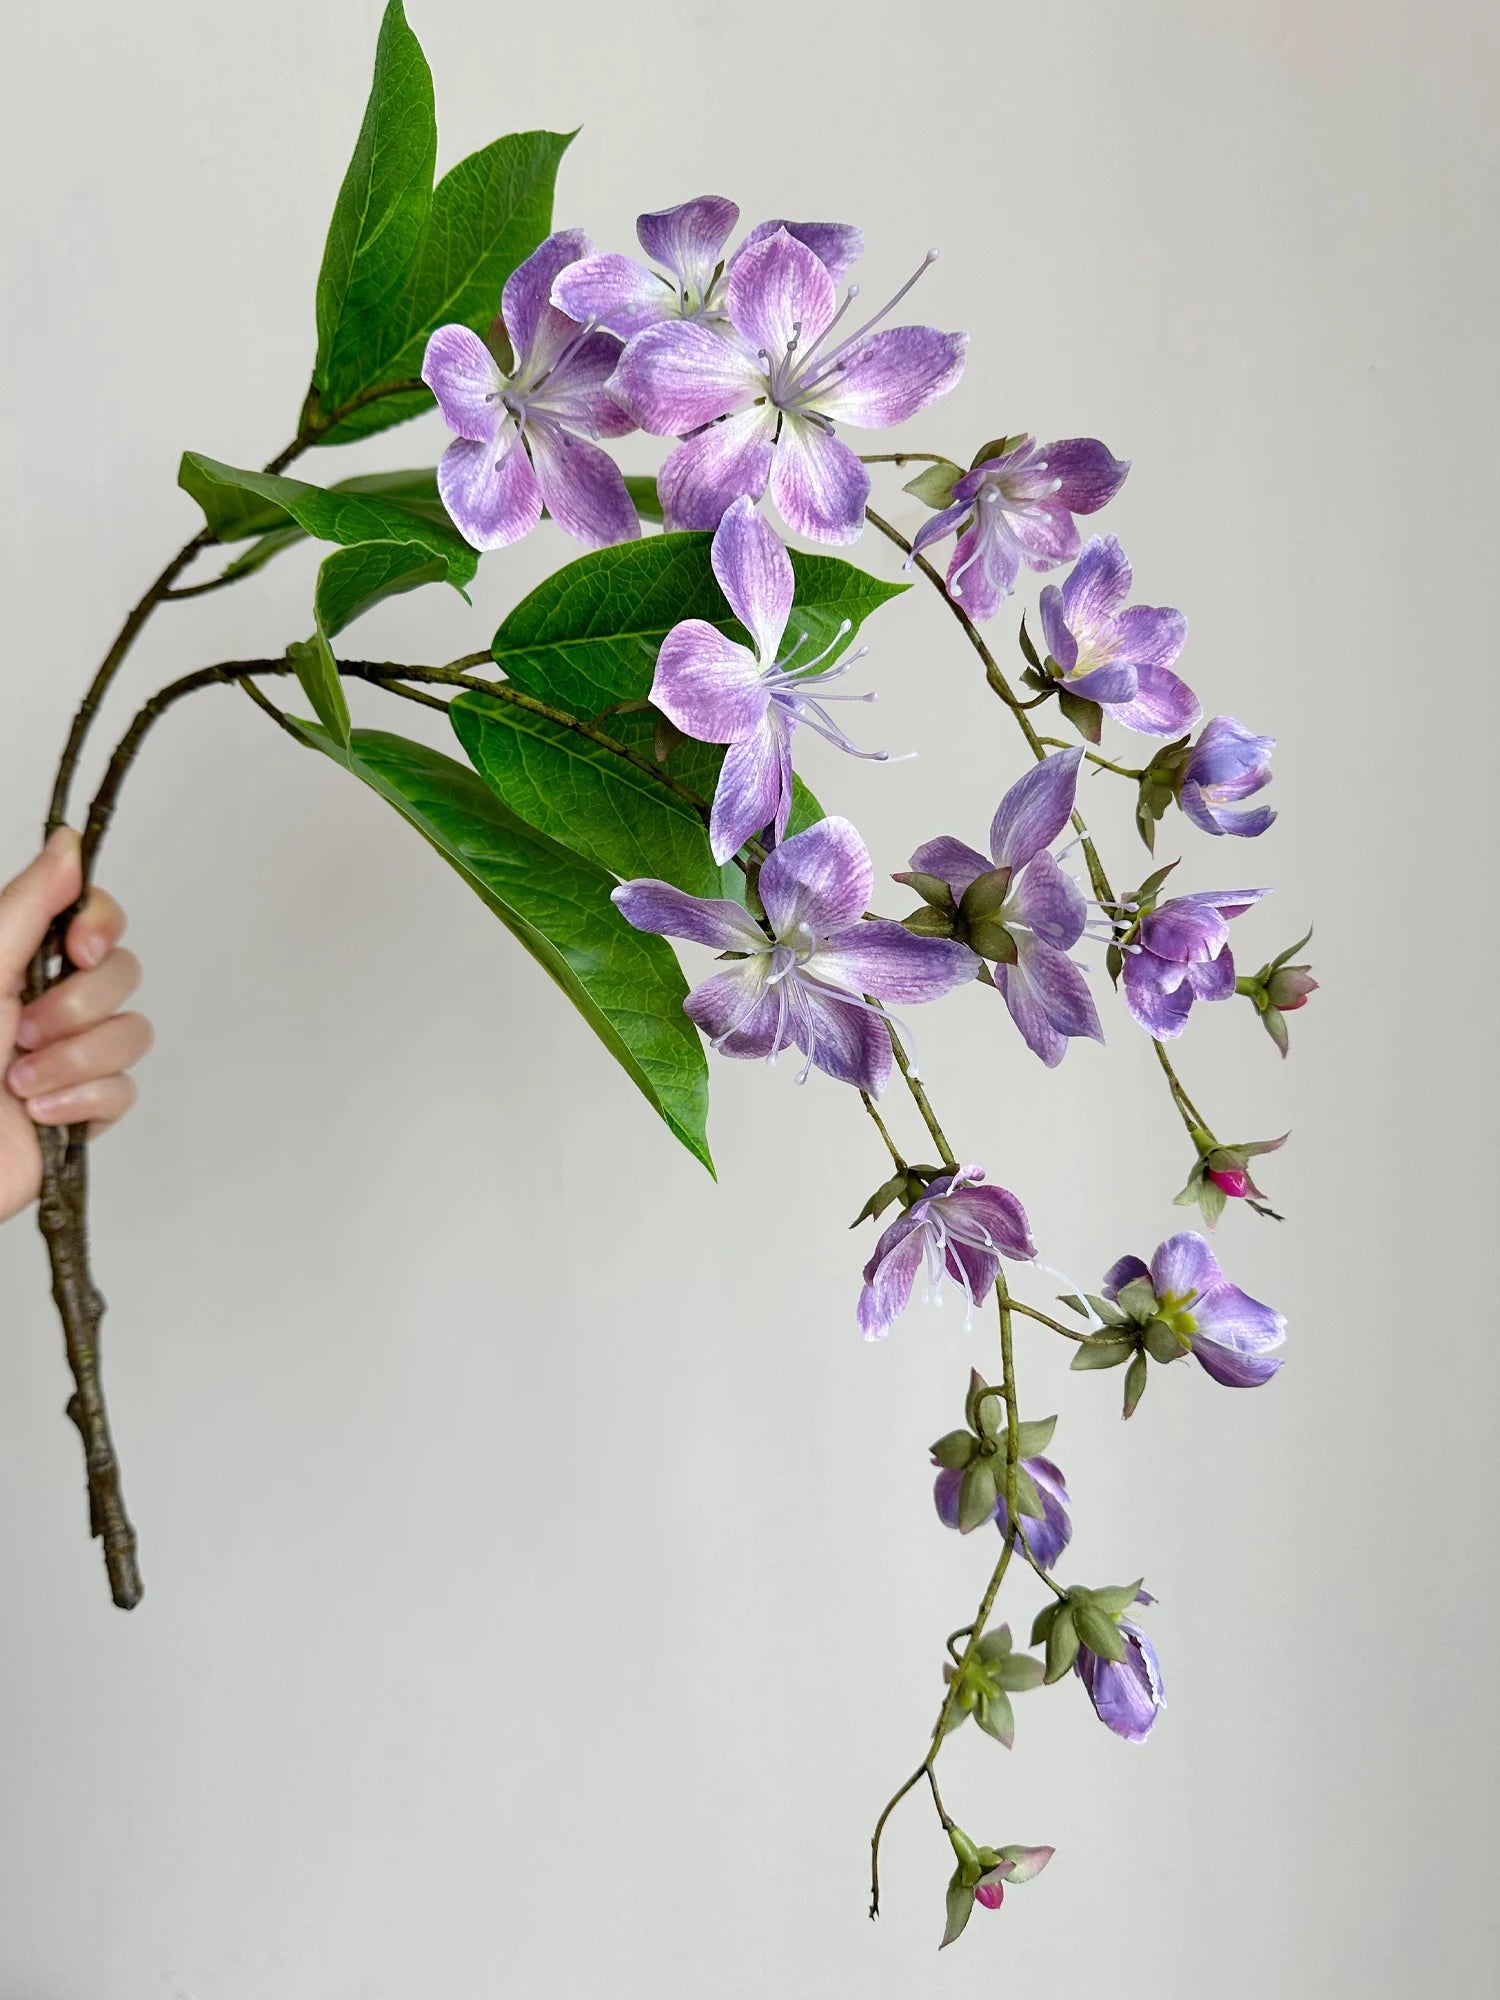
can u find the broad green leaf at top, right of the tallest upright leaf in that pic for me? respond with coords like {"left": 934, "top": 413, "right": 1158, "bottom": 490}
{"left": 314, "top": 128, "right": 572, "bottom": 444}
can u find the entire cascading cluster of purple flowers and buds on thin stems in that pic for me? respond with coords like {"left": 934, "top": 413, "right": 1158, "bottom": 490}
{"left": 408, "top": 180, "right": 1316, "bottom": 1944}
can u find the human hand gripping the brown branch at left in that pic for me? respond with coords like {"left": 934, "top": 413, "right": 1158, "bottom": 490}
{"left": 0, "top": 828, "right": 152, "bottom": 1222}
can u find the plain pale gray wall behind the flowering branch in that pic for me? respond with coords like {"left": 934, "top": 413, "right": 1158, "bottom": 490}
{"left": 0, "top": 0, "right": 1500, "bottom": 2000}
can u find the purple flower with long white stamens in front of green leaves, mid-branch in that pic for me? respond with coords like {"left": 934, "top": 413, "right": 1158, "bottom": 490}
{"left": 652, "top": 496, "right": 886, "bottom": 862}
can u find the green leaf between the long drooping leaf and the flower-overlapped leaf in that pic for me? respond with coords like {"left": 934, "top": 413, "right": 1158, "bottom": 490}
{"left": 448, "top": 694, "right": 722, "bottom": 896}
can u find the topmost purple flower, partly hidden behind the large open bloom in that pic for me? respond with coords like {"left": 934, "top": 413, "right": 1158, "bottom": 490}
{"left": 552, "top": 194, "right": 864, "bottom": 340}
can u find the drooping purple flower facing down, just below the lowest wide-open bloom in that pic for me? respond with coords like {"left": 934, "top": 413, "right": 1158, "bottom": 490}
{"left": 864, "top": 1168, "right": 1036, "bottom": 1340}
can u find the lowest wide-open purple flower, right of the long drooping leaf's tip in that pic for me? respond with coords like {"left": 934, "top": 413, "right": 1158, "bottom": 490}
{"left": 614, "top": 818, "right": 974, "bottom": 1098}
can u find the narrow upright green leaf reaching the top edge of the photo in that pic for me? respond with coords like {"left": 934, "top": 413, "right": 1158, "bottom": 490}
{"left": 312, "top": 0, "right": 434, "bottom": 406}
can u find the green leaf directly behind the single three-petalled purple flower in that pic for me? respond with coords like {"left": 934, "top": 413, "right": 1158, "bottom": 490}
{"left": 490, "top": 534, "right": 908, "bottom": 720}
